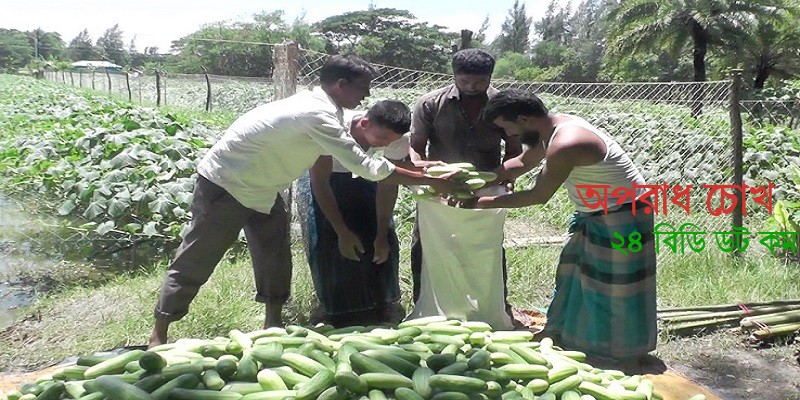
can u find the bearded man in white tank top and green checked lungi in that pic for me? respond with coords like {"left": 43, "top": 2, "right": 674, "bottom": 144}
{"left": 464, "top": 90, "right": 657, "bottom": 366}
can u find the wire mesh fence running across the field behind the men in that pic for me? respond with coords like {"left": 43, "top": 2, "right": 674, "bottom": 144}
{"left": 34, "top": 44, "right": 800, "bottom": 260}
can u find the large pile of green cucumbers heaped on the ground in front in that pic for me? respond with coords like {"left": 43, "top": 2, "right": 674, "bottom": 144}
{"left": 0, "top": 317, "right": 704, "bottom": 400}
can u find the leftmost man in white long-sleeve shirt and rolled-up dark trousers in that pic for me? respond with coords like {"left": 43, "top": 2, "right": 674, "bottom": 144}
{"left": 149, "top": 55, "right": 462, "bottom": 347}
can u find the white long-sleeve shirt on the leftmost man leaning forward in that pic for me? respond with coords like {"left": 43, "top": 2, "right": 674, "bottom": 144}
{"left": 197, "top": 87, "right": 394, "bottom": 213}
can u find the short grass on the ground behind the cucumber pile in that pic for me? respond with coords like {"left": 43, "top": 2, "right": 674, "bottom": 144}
{"left": 0, "top": 222, "right": 800, "bottom": 370}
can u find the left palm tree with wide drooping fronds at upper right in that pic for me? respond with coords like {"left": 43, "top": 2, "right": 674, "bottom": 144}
{"left": 608, "top": 0, "right": 788, "bottom": 82}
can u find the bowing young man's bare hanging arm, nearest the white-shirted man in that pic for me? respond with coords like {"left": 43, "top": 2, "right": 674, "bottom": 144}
{"left": 308, "top": 156, "right": 364, "bottom": 260}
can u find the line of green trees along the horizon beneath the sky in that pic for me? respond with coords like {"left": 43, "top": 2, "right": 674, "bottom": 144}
{"left": 0, "top": 0, "right": 800, "bottom": 89}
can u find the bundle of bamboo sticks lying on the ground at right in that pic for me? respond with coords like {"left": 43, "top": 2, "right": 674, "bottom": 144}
{"left": 658, "top": 299, "right": 800, "bottom": 342}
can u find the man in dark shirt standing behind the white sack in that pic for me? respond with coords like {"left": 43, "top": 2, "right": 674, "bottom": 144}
{"left": 409, "top": 49, "right": 522, "bottom": 320}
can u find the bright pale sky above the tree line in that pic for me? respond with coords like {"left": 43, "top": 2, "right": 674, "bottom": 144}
{"left": 0, "top": 0, "right": 567, "bottom": 51}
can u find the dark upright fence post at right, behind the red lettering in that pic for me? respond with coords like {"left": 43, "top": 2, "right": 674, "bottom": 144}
{"left": 730, "top": 69, "right": 744, "bottom": 255}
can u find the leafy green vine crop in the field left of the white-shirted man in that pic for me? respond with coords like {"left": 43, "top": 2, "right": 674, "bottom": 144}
{"left": 0, "top": 73, "right": 219, "bottom": 245}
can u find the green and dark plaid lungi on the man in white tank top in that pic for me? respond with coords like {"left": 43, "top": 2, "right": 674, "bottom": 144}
{"left": 545, "top": 205, "right": 657, "bottom": 359}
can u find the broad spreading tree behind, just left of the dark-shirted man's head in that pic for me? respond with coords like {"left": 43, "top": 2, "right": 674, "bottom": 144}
{"left": 314, "top": 8, "right": 457, "bottom": 72}
